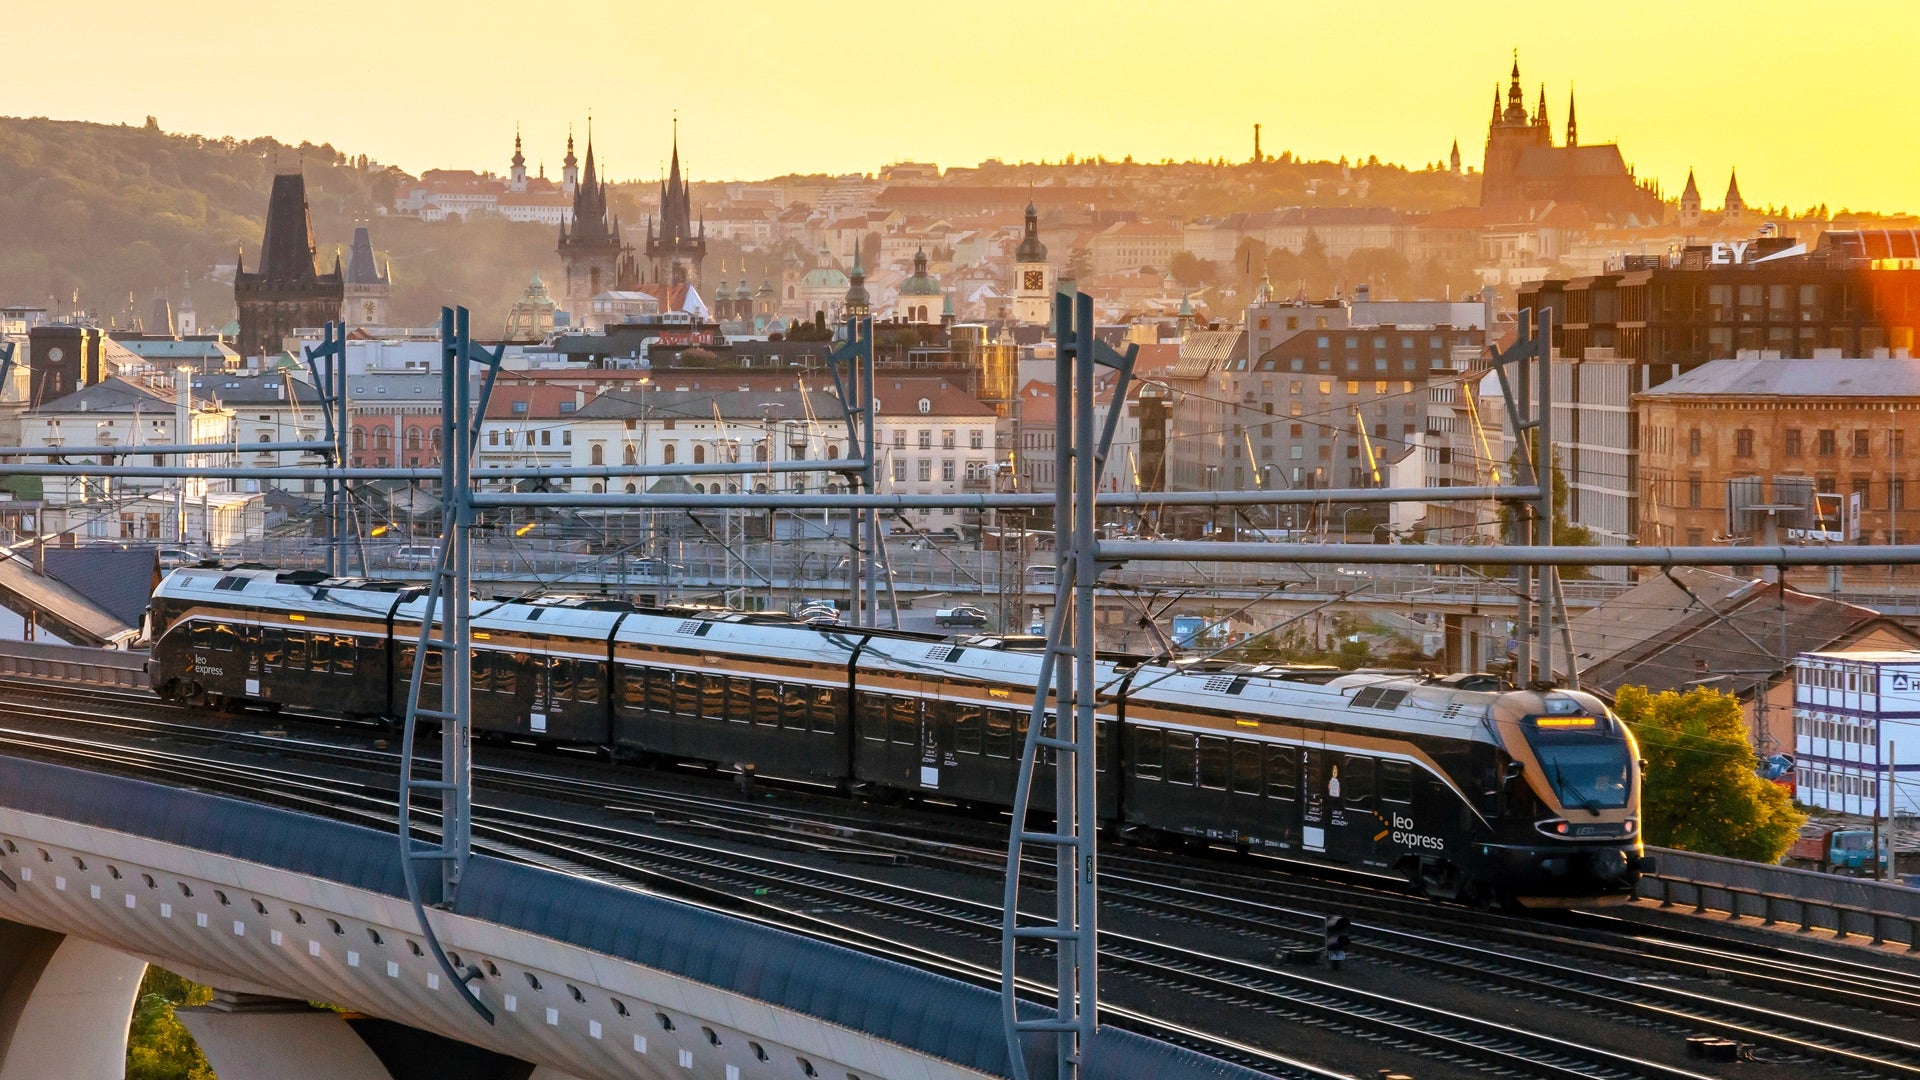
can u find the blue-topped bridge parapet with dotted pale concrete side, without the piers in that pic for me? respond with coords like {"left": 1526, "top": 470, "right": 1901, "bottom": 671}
{"left": 0, "top": 757, "right": 1254, "bottom": 1080}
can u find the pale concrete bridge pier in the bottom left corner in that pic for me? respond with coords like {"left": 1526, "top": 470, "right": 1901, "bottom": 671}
{"left": 0, "top": 920, "right": 146, "bottom": 1080}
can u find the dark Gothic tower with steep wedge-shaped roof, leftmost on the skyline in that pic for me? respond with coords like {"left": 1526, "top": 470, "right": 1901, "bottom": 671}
{"left": 234, "top": 173, "right": 346, "bottom": 356}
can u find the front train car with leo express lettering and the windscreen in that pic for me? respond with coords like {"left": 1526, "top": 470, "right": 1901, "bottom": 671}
{"left": 1123, "top": 665, "right": 1644, "bottom": 907}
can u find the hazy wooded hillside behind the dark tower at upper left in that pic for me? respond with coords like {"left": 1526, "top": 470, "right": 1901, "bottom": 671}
{"left": 0, "top": 117, "right": 557, "bottom": 327}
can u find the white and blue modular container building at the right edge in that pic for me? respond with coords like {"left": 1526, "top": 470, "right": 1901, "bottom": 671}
{"left": 1793, "top": 650, "right": 1920, "bottom": 817}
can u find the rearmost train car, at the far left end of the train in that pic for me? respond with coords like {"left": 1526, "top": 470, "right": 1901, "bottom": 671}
{"left": 148, "top": 569, "right": 409, "bottom": 717}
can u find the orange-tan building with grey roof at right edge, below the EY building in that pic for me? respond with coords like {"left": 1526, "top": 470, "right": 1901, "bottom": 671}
{"left": 1634, "top": 350, "right": 1920, "bottom": 546}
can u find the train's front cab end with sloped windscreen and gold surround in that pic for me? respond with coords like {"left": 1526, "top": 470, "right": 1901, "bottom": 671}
{"left": 1480, "top": 690, "right": 1645, "bottom": 907}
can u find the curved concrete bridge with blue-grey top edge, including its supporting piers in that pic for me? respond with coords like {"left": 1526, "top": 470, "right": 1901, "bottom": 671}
{"left": 0, "top": 757, "right": 1256, "bottom": 1080}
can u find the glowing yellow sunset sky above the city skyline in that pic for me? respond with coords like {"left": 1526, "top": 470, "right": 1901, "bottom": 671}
{"left": 15, "top": 0, "right": 1920, "bottom": 211}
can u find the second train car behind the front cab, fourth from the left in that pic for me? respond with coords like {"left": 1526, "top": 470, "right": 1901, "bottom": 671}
{"left": 852, "top": 634, "right": 1123, "bottom": 821}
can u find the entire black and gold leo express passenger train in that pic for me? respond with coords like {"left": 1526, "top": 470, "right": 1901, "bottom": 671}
{"left": 150, "top": 569, "right": 1644, "bottom": 907}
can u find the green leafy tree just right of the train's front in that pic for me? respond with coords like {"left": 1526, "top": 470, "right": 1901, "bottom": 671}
{"left": 1613, "top": 686, "right": 1807, "bottom": 863}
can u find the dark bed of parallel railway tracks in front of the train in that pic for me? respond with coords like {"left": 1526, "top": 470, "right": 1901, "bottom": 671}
{"left": 0, "top": 682, "right": 1920, "bottom": 1080}
